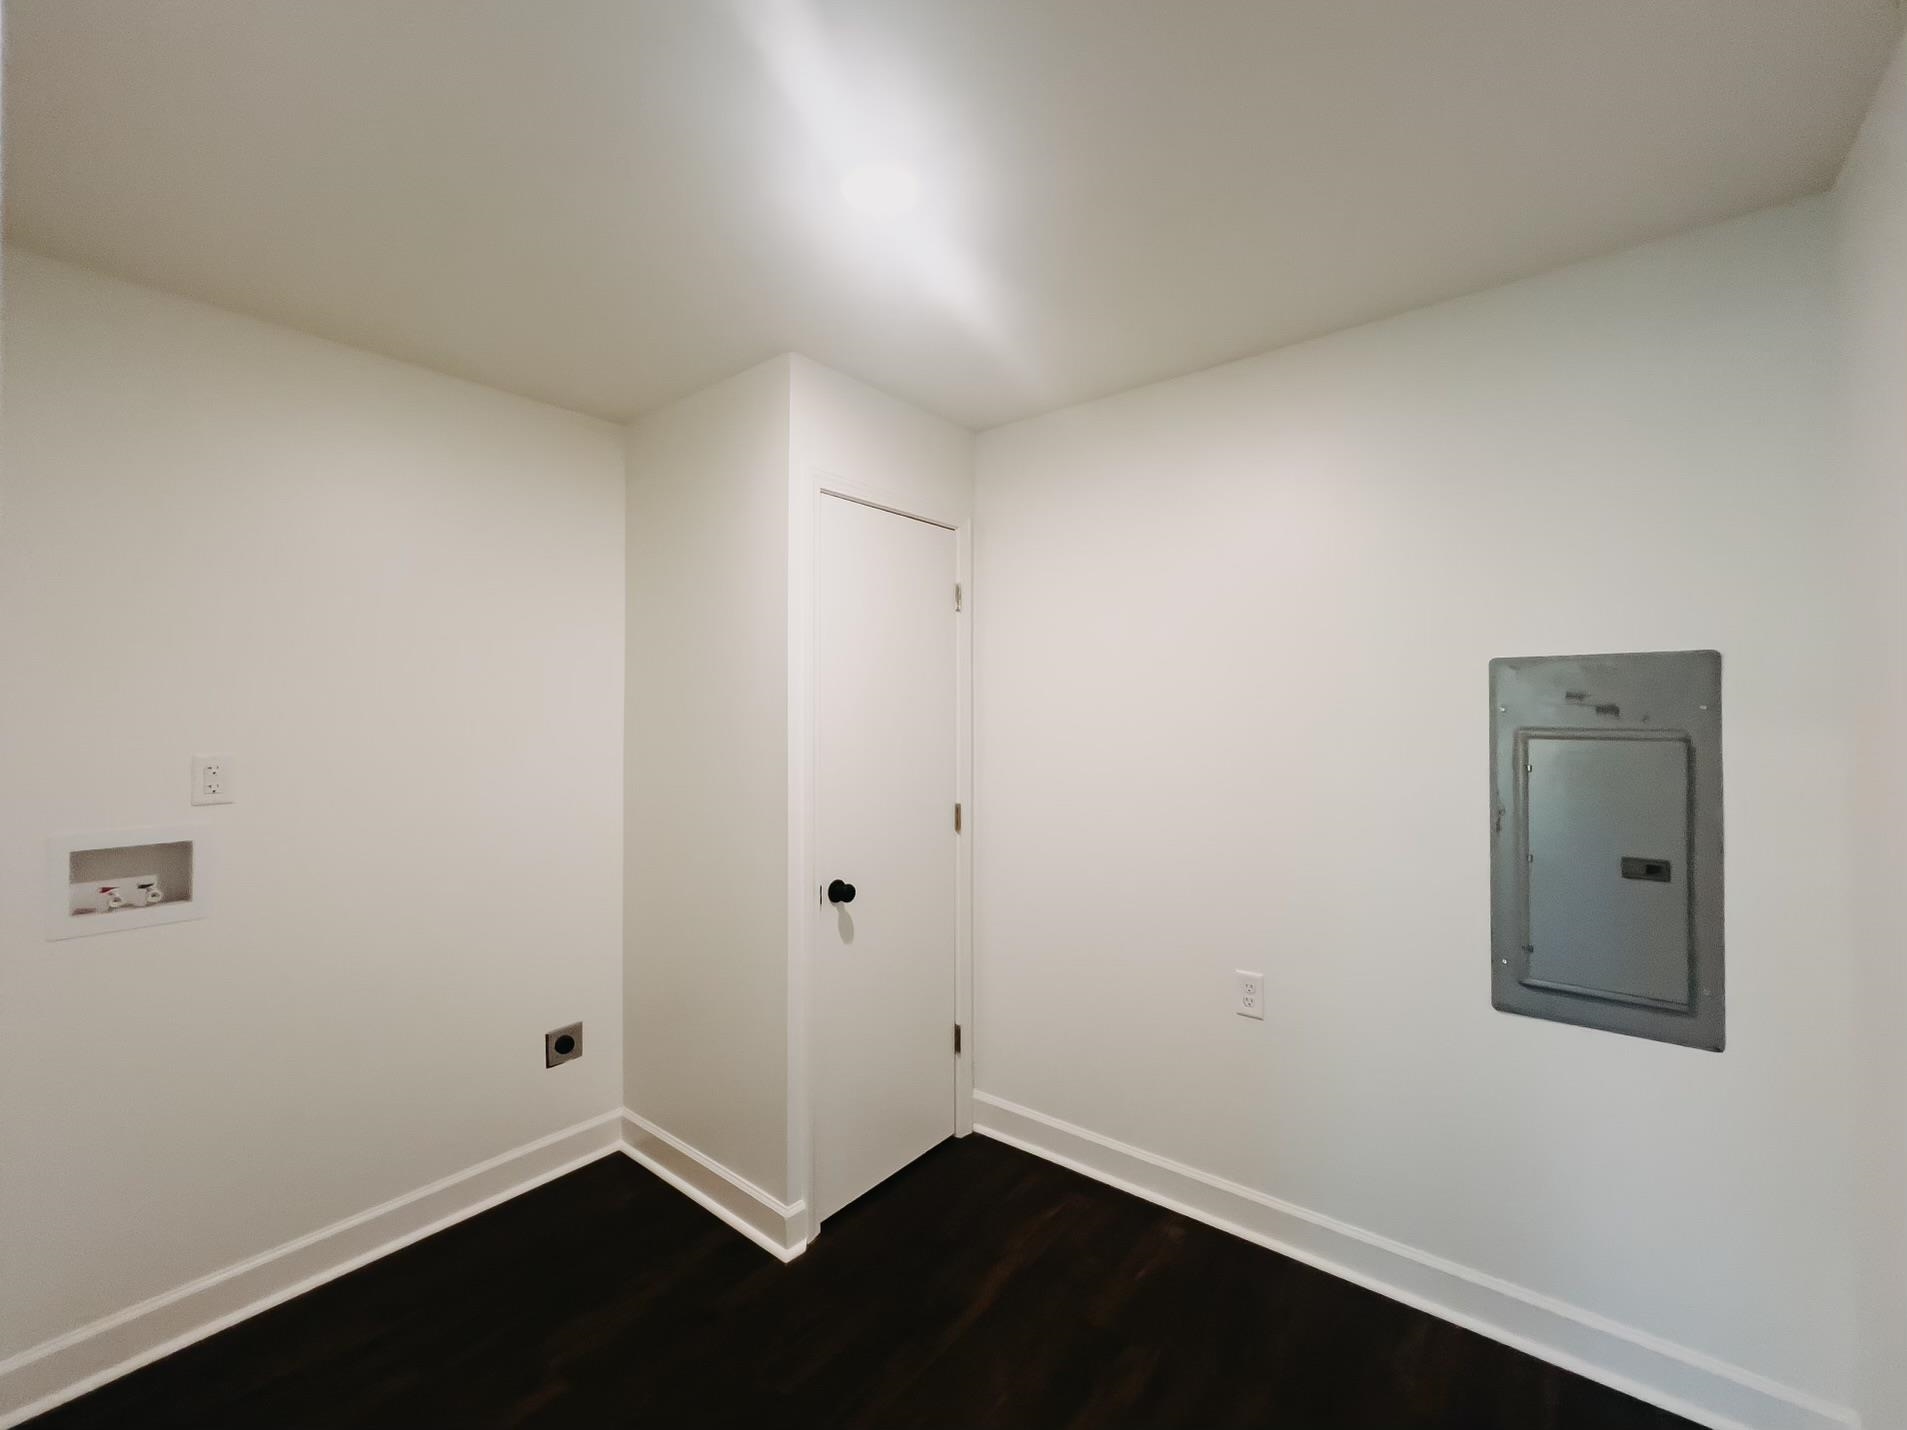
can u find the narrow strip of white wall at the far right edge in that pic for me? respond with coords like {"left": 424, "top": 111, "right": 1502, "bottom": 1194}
{"left": 1835, "top": 30, "right": 1907, "bottom": 1428}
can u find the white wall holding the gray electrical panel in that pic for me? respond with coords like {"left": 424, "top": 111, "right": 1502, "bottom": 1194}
{"left": 974, "top": 200, "right": 1854, "bottom": 1401}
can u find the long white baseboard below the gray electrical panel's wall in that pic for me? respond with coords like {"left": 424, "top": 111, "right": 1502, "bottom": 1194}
{"left": 973, "top": 1093, "right": 1859, "bottom": 1430}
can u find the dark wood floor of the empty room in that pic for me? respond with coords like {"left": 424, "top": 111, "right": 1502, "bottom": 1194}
{"left": 32, "top": 1136, "right": 1688, "bottom": 1430}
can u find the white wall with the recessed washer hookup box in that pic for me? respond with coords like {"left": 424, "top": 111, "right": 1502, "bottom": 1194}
{"left": 0, "top": 250, "right": 624, "bottom": 1358}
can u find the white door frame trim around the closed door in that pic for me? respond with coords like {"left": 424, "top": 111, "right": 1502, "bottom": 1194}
{"left": 788, "top": 463, "right": 974, "bottom": 1241}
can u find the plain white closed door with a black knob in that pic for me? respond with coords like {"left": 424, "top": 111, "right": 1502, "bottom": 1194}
{"left": 809, "top": 496, "right": 955, "bottom": 1216}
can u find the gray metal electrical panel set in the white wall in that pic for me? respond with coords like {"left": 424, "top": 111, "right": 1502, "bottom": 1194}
{"left": 1489, "top": 650, "right": 1724, "bottom": 1052}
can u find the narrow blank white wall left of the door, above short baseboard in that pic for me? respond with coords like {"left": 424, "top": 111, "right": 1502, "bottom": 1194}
{"left": 624, "top": 357, "right": 789, "bottom": 1199}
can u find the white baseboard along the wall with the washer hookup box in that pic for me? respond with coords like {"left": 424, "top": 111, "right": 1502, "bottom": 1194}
{"left": 0, "top": 1112, "right": 622, "bottom": 1430}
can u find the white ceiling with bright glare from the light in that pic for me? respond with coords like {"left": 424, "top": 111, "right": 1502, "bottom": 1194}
{"left": 4, "top": 0, "right": 1899, "bottom": 427}
